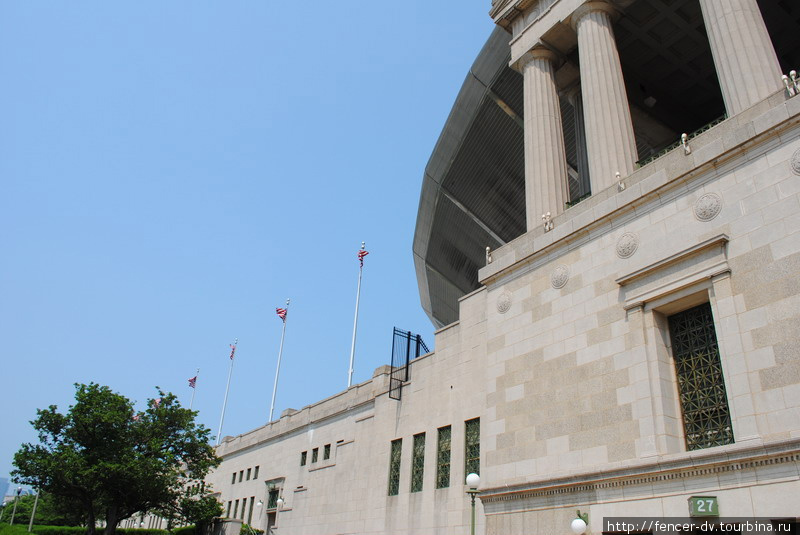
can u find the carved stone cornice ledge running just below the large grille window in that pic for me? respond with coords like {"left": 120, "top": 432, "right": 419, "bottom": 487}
{"left": 480, "top": 439, "right": 800, "bottom": 505}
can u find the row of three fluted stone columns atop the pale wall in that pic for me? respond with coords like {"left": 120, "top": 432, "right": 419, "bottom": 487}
{"left": 517, "top": 0, "right": 782, "bottom": 230}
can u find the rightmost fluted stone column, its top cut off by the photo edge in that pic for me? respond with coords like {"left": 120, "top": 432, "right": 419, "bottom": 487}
{"left": 700, "top": 0, "right": 783, "bottom": 115}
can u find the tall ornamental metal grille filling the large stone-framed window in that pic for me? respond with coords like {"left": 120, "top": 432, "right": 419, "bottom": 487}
{"left": 669, "top": 303, "right": 733, "bottom": 450}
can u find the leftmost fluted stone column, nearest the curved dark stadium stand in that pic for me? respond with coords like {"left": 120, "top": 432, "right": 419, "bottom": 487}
{"left": 518, "top": 48, "right": 569, "bottom": 230}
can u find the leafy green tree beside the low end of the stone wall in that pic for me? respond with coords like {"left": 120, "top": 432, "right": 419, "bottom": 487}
{"left": 12, "top": 383, "right": 219, "bottom": 535}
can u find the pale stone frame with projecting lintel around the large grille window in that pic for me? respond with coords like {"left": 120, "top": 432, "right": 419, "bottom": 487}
{"left": 616, "top": 234, "right": 758, "bottom": 458}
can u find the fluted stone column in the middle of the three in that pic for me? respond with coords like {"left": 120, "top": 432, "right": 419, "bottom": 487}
{"left": 572, "top": 2, "right": 637, "bottom": 194}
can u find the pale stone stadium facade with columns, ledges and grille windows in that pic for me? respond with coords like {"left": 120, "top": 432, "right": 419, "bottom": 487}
{"left": 194, "top": 0, "right": 800, "bottom": 535}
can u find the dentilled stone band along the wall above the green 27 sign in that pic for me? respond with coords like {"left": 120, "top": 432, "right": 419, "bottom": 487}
{"left": 480, "top": 438, "right": 800, "bottom": 508}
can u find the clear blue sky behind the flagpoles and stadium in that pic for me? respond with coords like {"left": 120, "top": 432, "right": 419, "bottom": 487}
{"left": 0, "top": 0, "right": 493, "bottom": 486}
